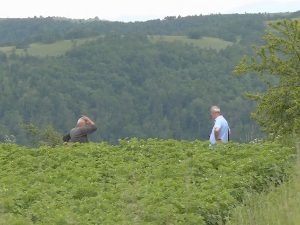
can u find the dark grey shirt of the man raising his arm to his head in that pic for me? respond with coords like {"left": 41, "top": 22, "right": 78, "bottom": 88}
{"left": 63, "top": 125, "right": 97, "bottom": 143}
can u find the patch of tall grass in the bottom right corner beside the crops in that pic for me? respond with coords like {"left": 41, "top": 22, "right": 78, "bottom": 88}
{"left": 227, "top": 160, "right": 300, "bottom": 225}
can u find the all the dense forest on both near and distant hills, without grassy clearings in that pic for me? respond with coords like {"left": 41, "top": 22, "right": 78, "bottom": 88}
{"left": 0, "top": 12, "right": 299, "bottom": 145}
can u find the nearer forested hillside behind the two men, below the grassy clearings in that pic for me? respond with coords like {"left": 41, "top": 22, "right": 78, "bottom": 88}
{"left": 0, "top": 34, "right": 262, "bottom": 146}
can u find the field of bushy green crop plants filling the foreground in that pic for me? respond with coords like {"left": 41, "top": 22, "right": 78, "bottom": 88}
{"left": 0, "top": 139, "right": 295, "bottom": 225}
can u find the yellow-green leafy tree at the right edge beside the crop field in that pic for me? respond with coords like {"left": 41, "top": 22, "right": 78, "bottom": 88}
{"left": 233, "top": 20, "right": 300, "bottom": 138}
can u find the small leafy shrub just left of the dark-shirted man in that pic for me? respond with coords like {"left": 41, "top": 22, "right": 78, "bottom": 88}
{"left": 21, "top": 123, "right": 62, "bottom": 147}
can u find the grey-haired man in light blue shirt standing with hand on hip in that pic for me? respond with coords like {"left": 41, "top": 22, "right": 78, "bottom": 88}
{"left": 209, "top": 106, "right": 231, "bottom": 144}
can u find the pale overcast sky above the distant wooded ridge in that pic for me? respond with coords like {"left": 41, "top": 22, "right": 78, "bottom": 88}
{"left": 0, "top": 0, "right": 300, "bottom": 21}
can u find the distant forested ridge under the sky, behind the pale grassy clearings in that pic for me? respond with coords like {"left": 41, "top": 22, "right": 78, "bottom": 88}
{"left": 0, "top": 12, "right": 299, "bottom": 46}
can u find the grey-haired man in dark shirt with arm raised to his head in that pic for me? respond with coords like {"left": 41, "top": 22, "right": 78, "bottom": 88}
{"left": 63, "top": 116, "right": 97, "bottom": 143}
